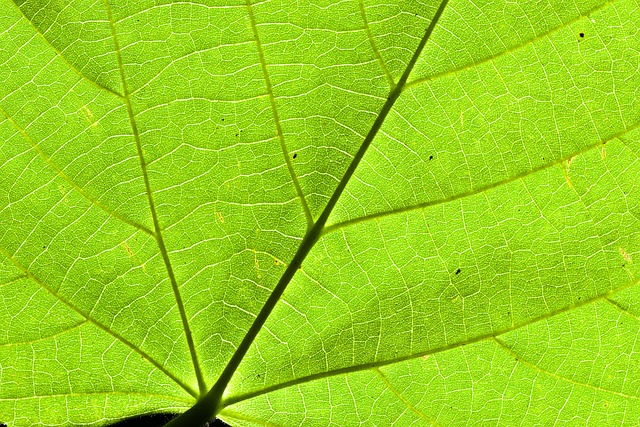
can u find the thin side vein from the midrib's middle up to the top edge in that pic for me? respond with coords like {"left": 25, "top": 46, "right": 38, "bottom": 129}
{"left": 246, "top": 0, "right": 313, "bottom": 230}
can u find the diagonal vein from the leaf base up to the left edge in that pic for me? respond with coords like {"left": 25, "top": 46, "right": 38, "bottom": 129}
{"left": 0, "top": 246, "right": 198, "bottom": 397}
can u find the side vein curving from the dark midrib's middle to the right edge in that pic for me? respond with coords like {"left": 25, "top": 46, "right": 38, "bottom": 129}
{"left": 323, "top": 116, "right": 640, "bottom": 234}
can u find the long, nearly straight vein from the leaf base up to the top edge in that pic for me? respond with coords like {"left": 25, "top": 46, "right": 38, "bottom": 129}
{"left": 103, "top": 0, "right": 207, "bottom": 394}
